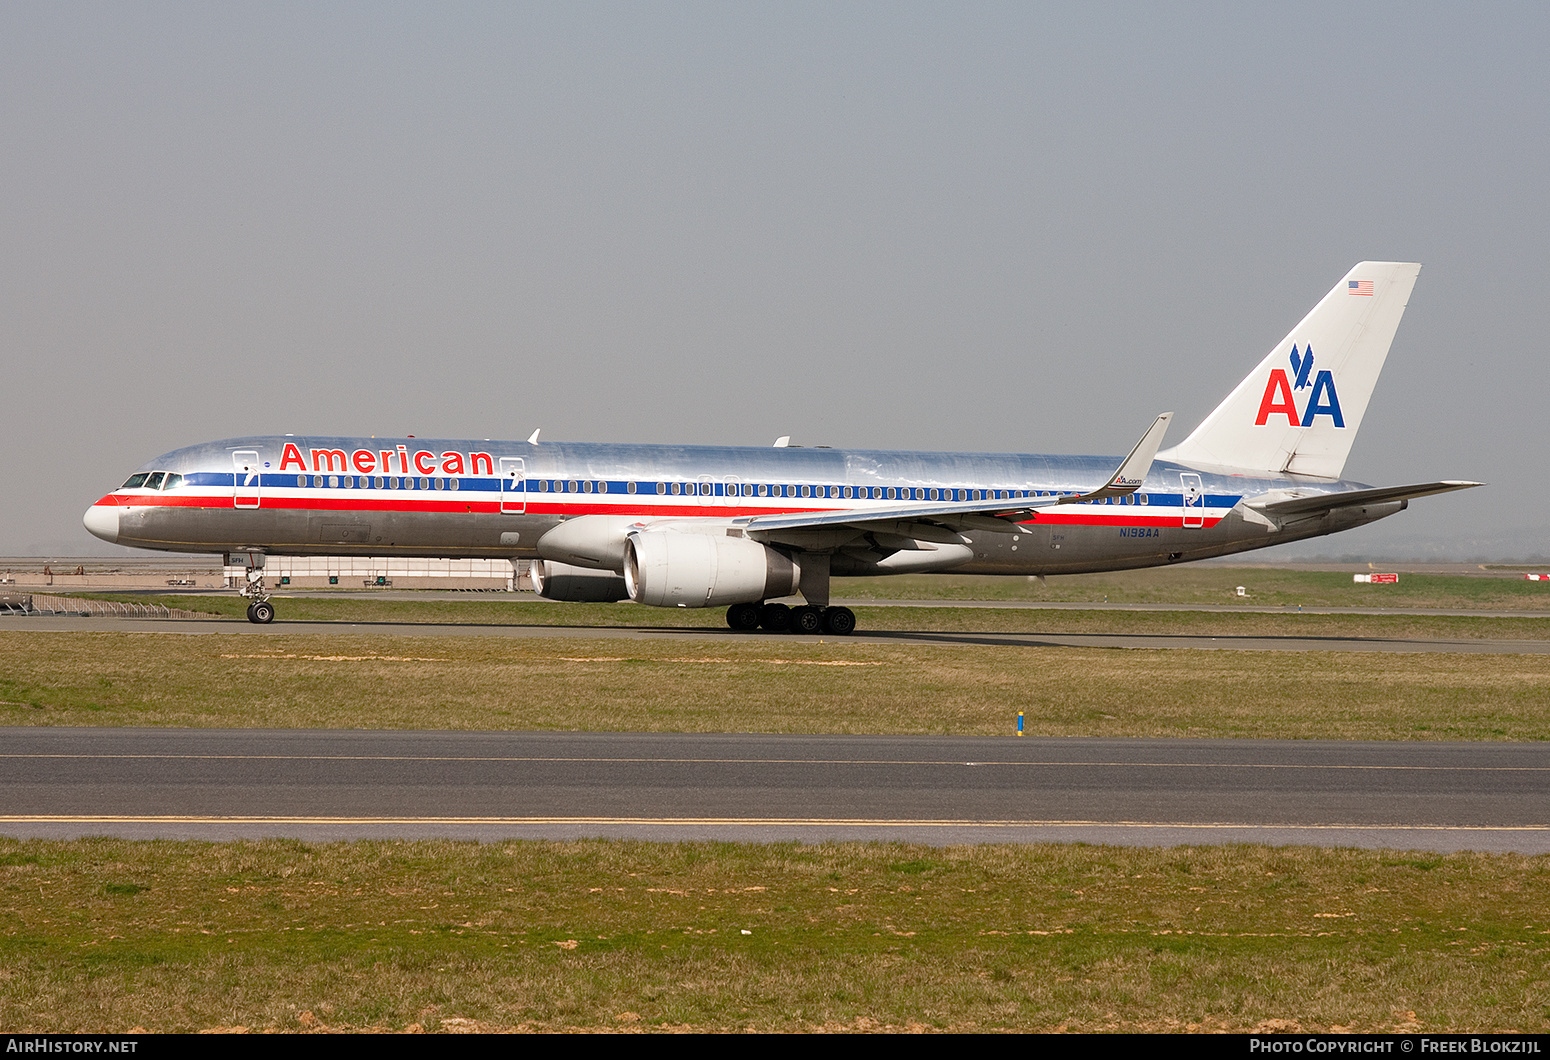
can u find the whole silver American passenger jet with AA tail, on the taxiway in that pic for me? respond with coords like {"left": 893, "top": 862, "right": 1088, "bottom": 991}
{"left": 84, "top": 262, "right": 1482, "bottom": 635}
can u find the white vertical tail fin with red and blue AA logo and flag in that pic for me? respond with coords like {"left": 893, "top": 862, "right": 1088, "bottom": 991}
{"left": 1158, "top": 262, "right": 1421, "bottom": 479}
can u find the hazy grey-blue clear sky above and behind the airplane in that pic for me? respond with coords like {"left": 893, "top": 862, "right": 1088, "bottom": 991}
{"left": 0, "top": 2, "right": 1550, "bottom": 559}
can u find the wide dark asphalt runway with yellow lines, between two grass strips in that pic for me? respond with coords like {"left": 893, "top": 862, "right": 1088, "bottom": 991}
{"left": 0, "top": 728, "right": 1550, "bottom": 854}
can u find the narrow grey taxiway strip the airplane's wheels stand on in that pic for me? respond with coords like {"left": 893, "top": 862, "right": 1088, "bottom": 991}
{"left": 9, "top": 615, "right": 1550, "bottom": 656}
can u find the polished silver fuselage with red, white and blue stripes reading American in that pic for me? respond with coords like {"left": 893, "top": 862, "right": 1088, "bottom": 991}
{"left": 87, "top": 435, "right": 1404, "bottom": 575}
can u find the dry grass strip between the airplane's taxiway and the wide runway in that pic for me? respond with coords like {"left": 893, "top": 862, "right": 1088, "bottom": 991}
{"left": 0, "top": 631, "right": 1550, "bottom": 741}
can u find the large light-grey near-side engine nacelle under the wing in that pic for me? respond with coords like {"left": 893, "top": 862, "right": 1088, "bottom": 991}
{"left": 625, "top": 530, "right": 801, "bottom": 607}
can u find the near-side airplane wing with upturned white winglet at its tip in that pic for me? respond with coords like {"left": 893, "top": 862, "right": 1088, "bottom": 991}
{"left": 744, "top": 412, "right": 1173, "bottom": 547}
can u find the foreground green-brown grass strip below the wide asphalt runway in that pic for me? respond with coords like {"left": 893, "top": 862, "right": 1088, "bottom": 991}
{"left": 0, "top": 840, "right": 1550, "bottom": 1034}
